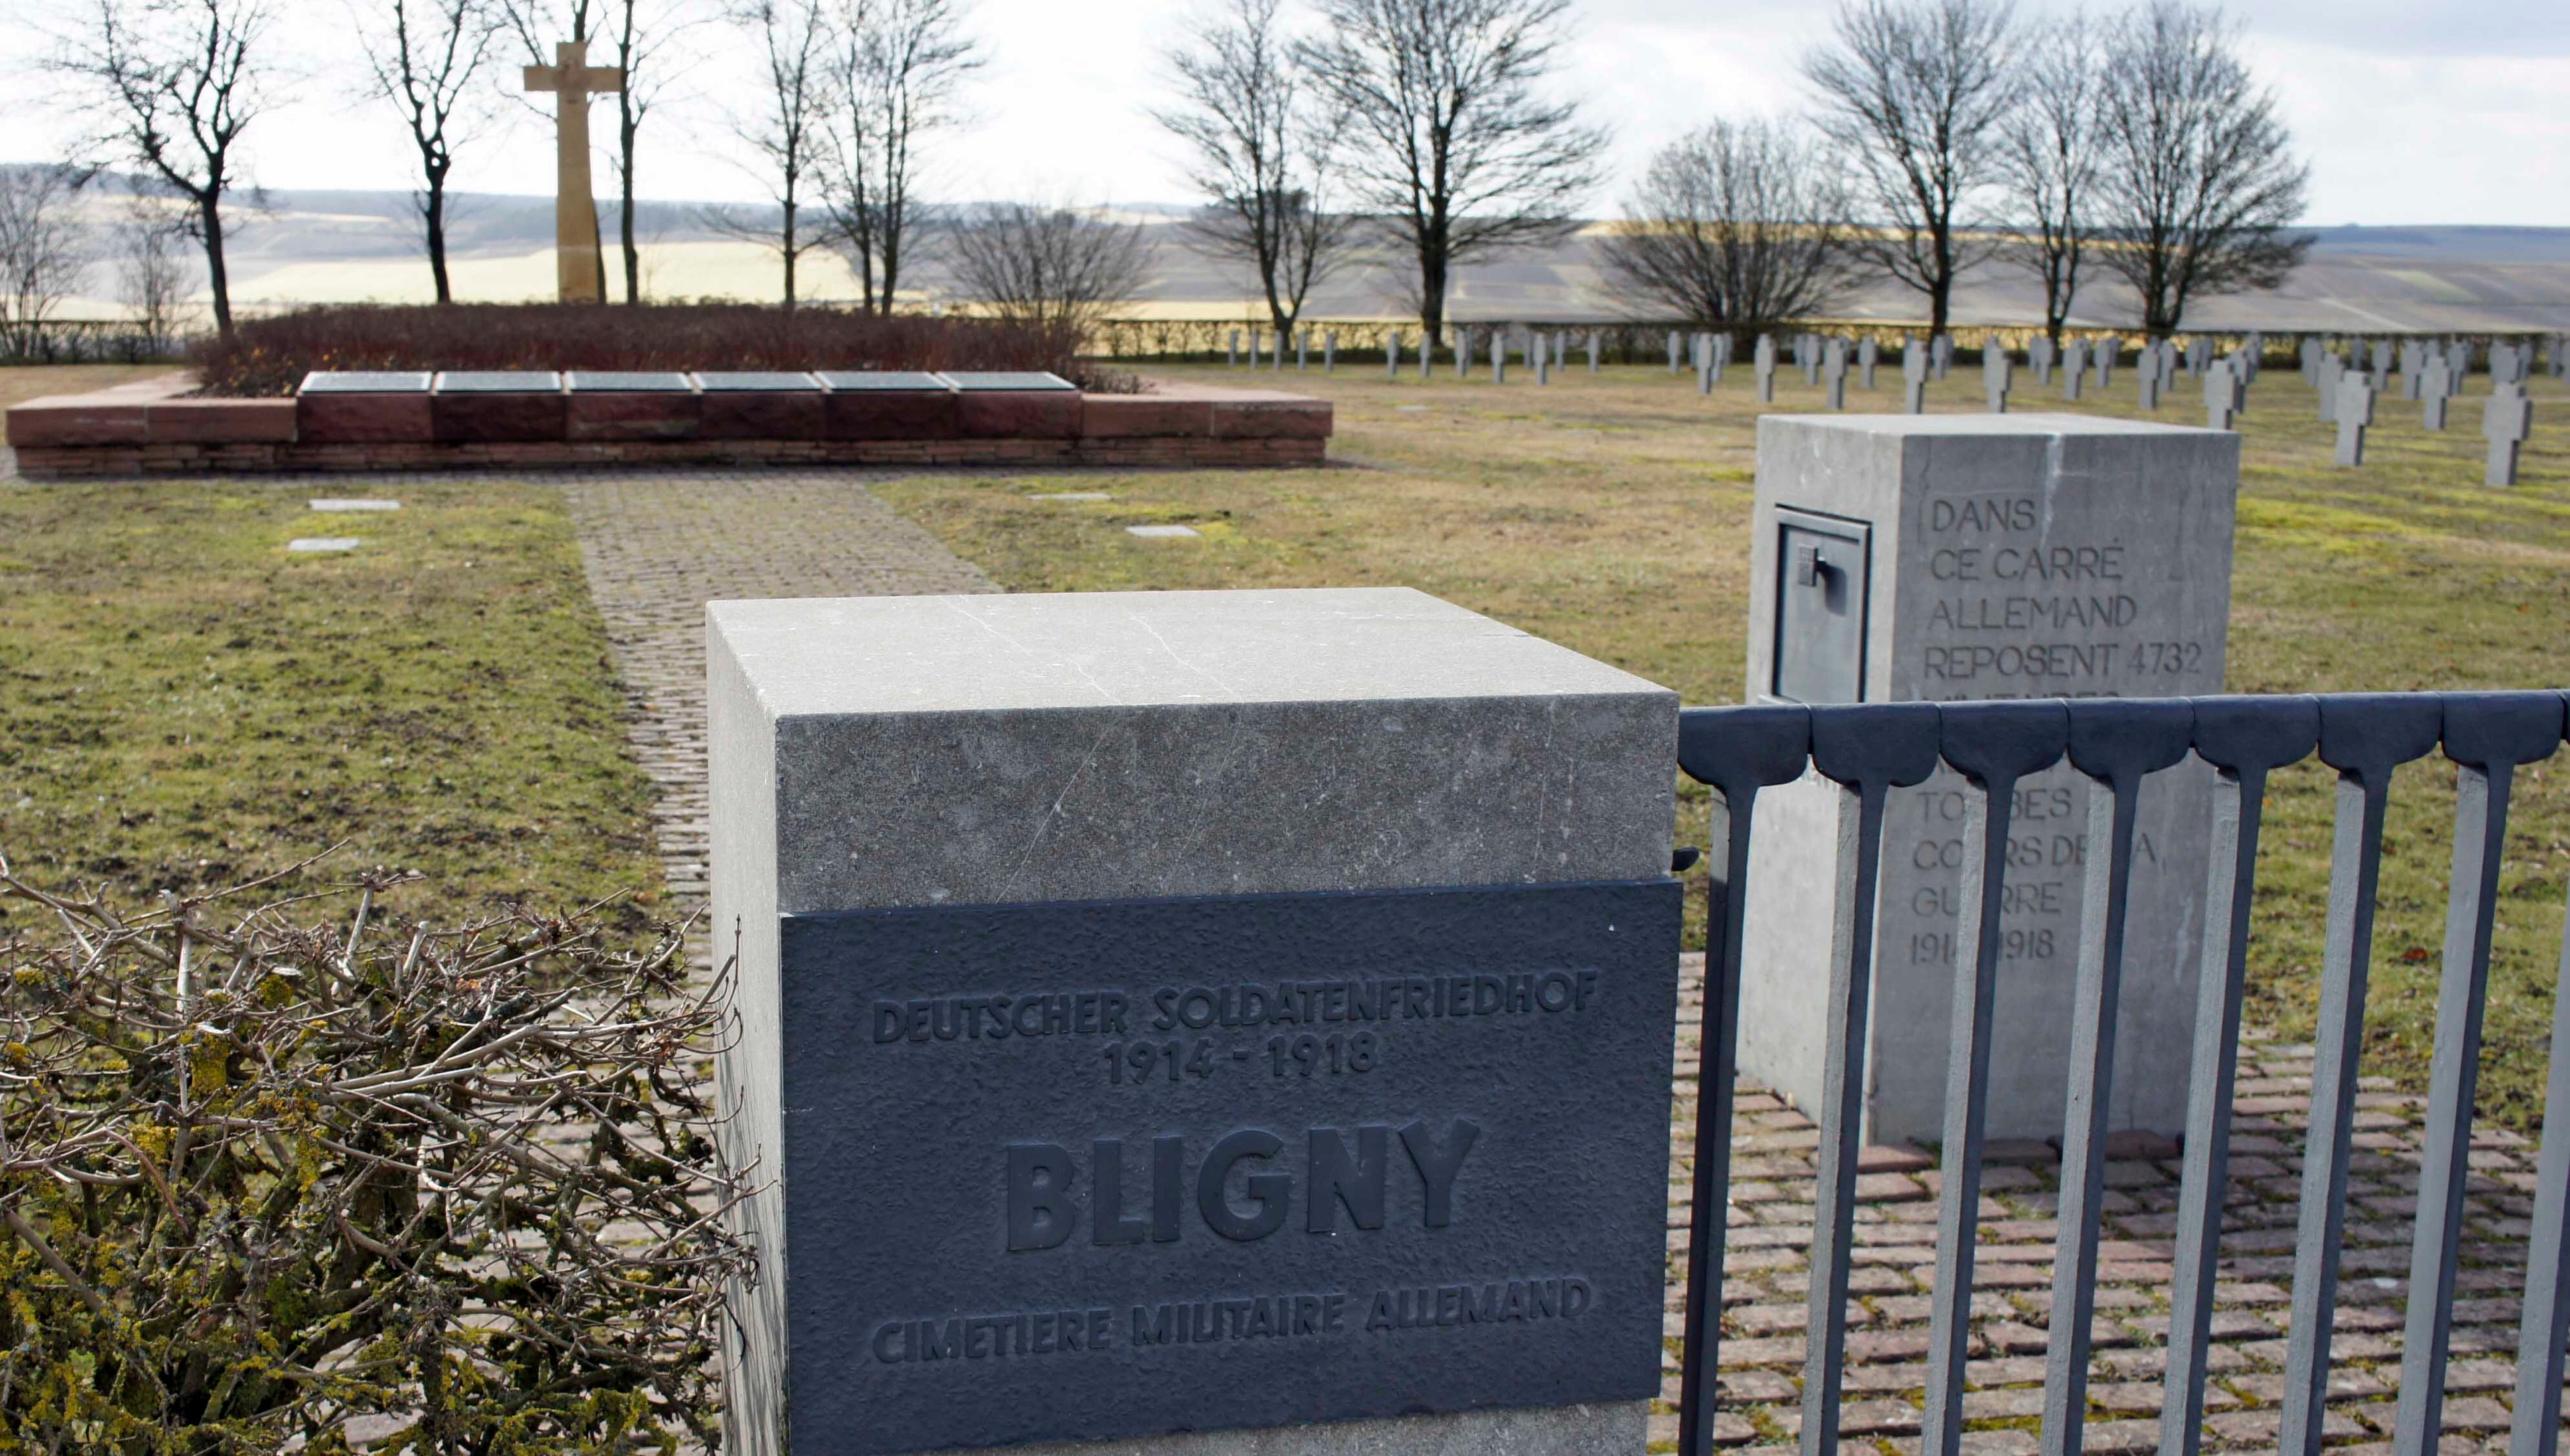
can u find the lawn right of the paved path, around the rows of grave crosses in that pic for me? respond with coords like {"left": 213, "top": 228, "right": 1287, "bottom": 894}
{"left": 876, "top": 365, "right": 2570, "bottom": 1127}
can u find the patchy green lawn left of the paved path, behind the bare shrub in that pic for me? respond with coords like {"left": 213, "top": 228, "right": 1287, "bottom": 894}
{"left": 0, "top": 421, "right": 661, "bottom": 935}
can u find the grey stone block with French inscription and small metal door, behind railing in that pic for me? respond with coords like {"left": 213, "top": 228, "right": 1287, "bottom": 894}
{"left": 1740, "top": 414, "right": 2239, "bottom": 1143}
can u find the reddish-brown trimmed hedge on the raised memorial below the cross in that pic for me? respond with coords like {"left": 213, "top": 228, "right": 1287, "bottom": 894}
{"left": 193, "top": 303, "right": 1133, "bottom": 398}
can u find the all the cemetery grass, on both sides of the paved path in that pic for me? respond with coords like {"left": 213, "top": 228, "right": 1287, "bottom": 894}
{"left": 0, "top": 362, "right": 2570, "bottom": 1127}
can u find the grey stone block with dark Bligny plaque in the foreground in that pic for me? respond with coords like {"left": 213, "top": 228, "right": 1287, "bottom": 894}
{"left": 707, "top": 588, "right": 1679, "bottom": 1456}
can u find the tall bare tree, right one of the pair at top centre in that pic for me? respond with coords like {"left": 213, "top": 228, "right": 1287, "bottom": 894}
{"left": 1293, "top": 0, "right": 1606, "bottom": 337}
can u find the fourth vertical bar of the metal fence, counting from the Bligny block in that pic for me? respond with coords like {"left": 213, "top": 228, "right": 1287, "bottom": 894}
{"left": 2043, "top": 699, "right": 2195, "bottom": 1456}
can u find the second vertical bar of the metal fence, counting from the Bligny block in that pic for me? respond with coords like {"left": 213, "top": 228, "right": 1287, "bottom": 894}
{"left": 1802, "top": 704, "right": 1938, "bottom": 1456}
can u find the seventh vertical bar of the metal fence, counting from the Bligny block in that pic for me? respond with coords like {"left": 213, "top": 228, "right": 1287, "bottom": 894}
{"left": 2393, "top": 693, "right": 2562, "bottom": 1453}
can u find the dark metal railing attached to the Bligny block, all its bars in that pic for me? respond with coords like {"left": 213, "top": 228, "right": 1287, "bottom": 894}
{"left": 1679, "top": 691, "right": 2570, "bottom": 1456}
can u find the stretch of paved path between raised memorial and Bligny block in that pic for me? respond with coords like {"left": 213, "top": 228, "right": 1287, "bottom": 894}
{"left": 558, "top": 470, "right": 1000, "bottom": 914}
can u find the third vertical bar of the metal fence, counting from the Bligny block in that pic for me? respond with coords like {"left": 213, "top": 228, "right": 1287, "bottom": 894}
{"left": 1919, "top": 701, "right": 2071, "bottom": 1456}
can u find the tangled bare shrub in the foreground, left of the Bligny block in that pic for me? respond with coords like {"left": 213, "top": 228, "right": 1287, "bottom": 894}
{"left": 0, "top": 862, "right": 748, "bottom": 1453}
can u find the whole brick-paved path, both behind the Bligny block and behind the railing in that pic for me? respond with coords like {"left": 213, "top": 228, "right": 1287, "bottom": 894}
{"left": 560, "top": 472, "right": 2534, "bottom": 1456}
